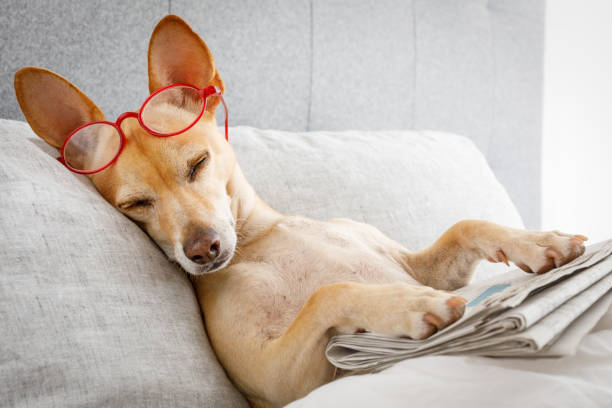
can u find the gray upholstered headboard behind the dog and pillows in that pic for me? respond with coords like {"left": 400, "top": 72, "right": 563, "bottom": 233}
{"left": 0, "top": 0, "right": 544, "bottom": 227}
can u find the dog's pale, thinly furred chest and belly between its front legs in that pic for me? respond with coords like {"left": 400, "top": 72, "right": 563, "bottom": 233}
{"left": 230, "top": 217, "right": 416, "bottom": 338}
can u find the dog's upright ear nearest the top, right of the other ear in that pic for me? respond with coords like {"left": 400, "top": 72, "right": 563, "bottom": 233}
{"left": 149, "top": 15, "right": 225, "bottom": 112}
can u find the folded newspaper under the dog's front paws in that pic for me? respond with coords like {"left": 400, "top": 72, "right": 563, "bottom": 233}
{"left": 326, "top": 240, "right": 612, "bottom": 371}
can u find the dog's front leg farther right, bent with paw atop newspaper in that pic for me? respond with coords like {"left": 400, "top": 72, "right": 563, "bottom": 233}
{"left": 401, "top": 220, "right": 586, "bottom": 290}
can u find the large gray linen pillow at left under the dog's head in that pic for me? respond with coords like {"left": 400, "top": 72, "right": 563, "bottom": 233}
{"left": 0, "top": 120, "right": 248, "bottom": 407}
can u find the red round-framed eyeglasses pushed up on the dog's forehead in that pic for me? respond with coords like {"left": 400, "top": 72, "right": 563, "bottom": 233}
{"left": 57, "top": 84, "right": 228, "bottom": 174}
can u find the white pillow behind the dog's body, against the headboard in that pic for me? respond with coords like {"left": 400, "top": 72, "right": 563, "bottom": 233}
{"left": 229, "top": 127, "right": 523, "bottom": 279}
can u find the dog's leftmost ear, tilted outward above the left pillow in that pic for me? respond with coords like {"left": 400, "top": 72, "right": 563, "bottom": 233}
{"left": 15, "top": 67, "right": 104, "bottom": 149}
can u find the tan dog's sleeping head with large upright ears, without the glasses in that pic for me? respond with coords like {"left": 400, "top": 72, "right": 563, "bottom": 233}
{"left": 15, "top": 16, "right": 237, "bottom": 275}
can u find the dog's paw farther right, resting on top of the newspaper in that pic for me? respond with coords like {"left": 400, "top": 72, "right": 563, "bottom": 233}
{"left": 490, "top": 231, "right": 587, "bottom": 274}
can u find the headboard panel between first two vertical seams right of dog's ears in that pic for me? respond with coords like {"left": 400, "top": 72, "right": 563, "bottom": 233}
{"left": 310, "top": 0, "right": 416, "bottom": 130}
